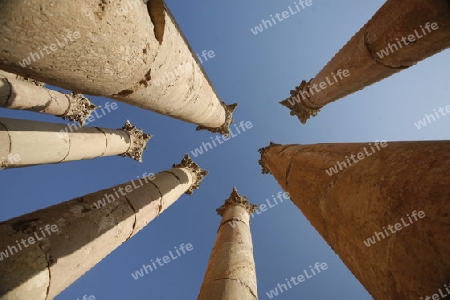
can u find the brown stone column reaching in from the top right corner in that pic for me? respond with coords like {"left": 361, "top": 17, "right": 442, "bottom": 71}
{"left": 280, "top": 0, "right": 450, "bottom": 124}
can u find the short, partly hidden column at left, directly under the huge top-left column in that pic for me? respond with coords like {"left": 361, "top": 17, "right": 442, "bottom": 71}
{"left": 0, "top": 70, "right": 97, "bottom": 125}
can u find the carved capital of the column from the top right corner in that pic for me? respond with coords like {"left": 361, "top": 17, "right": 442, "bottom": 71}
{"left": 280, "top": 79, "right": 320, "bottom": 124}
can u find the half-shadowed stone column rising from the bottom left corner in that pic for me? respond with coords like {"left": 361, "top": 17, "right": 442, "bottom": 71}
{"left": 0, "top": 156, "right": 207, "bottom": 300}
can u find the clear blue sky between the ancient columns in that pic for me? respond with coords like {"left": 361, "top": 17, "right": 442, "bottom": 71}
{"left": 0, "top": 0, "right": 450, "bottom": 300}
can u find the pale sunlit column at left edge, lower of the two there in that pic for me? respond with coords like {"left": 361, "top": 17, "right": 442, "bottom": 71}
{"left": 0, "top": 118, "right": 152, "bottom": 169}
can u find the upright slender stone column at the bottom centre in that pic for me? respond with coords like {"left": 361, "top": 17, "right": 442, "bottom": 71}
{"left": 198, "top": 188, "right": 258, "bottom": 300}
